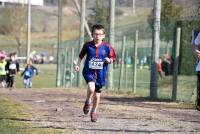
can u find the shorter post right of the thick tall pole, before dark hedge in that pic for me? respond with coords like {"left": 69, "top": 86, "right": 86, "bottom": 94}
{"left": 172, "top": 28, "right": 181, "bottom": 101}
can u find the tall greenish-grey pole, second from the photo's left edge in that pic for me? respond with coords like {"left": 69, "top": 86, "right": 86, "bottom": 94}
{"left": 56, "top": 0, "right": 62, "bottom": 87}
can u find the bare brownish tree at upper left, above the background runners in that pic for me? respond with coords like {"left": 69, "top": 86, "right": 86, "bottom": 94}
{"left": 0, "top": 5, "right": 26, "bottom": 55}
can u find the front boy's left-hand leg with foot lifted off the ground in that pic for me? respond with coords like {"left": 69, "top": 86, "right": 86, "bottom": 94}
{"left": 83, "top": 82, "right": 95, "bottom": 114}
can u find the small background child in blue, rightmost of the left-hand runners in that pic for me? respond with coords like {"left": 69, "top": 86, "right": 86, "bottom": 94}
{"left": 21, "top": 61, "right": 38, "bottom": 88}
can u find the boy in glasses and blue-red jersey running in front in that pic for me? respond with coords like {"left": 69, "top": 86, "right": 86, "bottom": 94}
{"left": 75, "top": 24, "right": 116, "bottom": 122}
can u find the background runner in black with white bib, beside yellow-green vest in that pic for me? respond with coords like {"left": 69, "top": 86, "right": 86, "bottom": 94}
{"left": 6, "top": 52, "right": 20, "bottom": 90}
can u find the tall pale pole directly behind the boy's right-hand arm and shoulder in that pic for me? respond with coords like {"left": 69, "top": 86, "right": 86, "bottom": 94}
{"left": 107, "top": 0, "right": 115, "bottom": 89}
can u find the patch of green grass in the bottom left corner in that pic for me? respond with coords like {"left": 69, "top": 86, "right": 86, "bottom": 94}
{"left": 0, "top": 97, "right": 61, "bottom": 134}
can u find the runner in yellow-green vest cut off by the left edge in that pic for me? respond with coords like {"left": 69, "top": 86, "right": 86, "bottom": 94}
{"left": 0, "top": 50, "right": 6, "bottom": 88}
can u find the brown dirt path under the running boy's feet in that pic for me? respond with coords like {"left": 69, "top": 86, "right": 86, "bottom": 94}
{"left": 0, "top": 89, "right": 200, "bottom": 134}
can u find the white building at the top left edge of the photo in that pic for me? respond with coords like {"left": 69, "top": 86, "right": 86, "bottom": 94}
{"left": 0, "top": 0, "right": 44, "bottom": 6}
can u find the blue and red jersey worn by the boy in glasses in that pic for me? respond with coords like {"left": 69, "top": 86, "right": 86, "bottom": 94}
{"left": 79, "top": 41, "right": 116, "bottom": 87}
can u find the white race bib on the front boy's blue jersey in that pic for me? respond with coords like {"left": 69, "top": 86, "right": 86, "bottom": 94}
{"left": 89, "top": 58, "right": 104, "bottom": 69}
